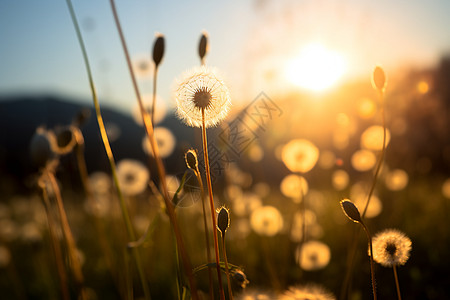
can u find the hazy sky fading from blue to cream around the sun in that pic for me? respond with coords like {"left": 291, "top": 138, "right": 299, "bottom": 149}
{"left": 0, "top": 0, "right": 450, "bottom": 112}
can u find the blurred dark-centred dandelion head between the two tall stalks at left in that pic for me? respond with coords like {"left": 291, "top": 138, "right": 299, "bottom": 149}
{"left": 117, "top": 159, "right": 150, "bottom": 196}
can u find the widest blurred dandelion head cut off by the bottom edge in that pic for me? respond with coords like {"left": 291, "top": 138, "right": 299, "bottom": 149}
{"left": 278, "top": 284, "right": 336, "bottom": 300}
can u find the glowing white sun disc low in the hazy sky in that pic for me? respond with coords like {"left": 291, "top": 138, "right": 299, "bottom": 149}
{"left": 285, "top": 44, "right": 346, "bottom": 91}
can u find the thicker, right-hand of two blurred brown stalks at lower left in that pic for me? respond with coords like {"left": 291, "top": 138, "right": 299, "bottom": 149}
{"left": 46, "top": 170, "right": 86, "bottom": 299}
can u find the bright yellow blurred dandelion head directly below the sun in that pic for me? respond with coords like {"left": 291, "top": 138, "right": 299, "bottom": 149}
{"left": 281, "top": 139, "right": 319, "bottom": 173}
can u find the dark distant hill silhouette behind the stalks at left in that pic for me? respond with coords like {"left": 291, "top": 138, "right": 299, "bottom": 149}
{"left": 0, "top": 96, "right": 194, "bottom": 198}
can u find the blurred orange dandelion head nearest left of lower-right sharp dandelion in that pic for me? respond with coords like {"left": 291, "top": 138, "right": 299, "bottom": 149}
{"left": 296, "top": 241, "right": 331, "bottom": 271}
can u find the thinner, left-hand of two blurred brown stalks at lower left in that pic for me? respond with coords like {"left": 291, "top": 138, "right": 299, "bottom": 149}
{"left": 41, "top": 186, "right": 70, "bottom": 300}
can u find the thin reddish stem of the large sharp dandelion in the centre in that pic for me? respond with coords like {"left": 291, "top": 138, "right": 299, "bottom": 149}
{"left": 202, "top": 108, "right": 225, "bottom": 300}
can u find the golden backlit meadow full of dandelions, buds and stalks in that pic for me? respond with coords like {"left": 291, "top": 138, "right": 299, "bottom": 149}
{"left": 0, "top": 1, "right": 450, "bottom": 300}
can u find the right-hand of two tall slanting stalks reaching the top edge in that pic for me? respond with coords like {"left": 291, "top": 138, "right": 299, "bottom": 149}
{"left": 110, "top": 0, "right": 199, "bottom": 300}
